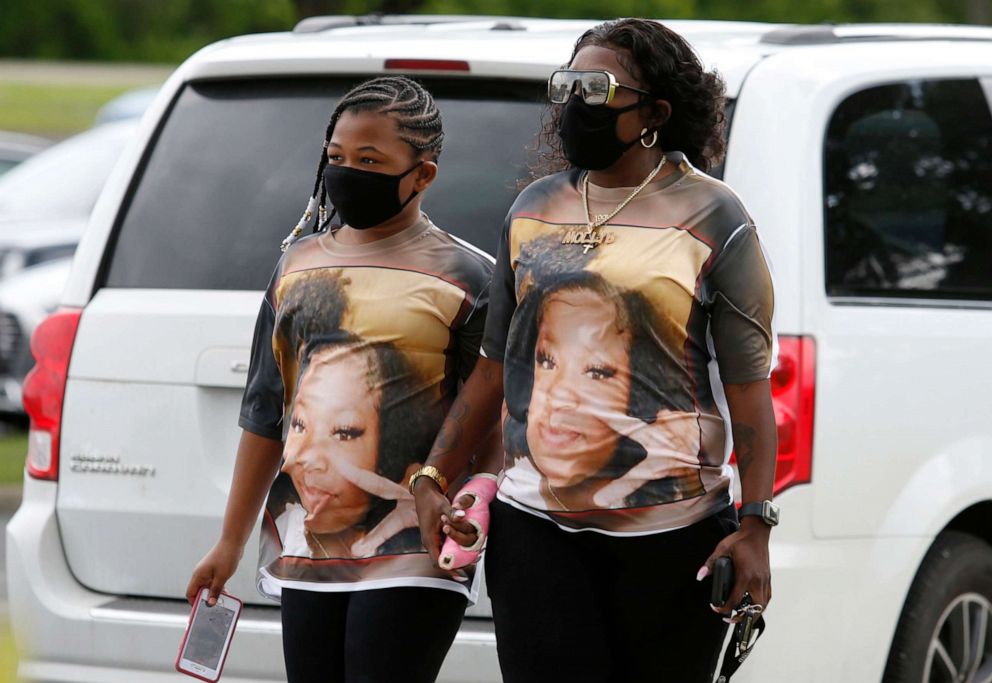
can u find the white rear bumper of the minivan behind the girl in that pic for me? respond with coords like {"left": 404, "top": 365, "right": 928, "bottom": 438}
{"left": 7, "top": 479, "right": 500, "bottom": 683}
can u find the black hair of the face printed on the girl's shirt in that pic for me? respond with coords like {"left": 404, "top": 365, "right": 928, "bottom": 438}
{"left": 275, "top": 268, "right": 443, "bottom": 540}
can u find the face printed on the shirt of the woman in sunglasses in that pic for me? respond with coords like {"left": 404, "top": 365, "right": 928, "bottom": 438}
{"left": 527, "top": 288, "right": 630, "bottom": 487}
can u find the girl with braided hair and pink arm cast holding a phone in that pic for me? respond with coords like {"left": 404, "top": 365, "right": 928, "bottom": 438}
{"left": 187, "top": 76, "right": 492, "bottom": 683}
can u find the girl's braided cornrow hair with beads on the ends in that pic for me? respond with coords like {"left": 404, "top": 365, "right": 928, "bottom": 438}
{"left": 282, "top": 76, "right": 444, "bottom": 251}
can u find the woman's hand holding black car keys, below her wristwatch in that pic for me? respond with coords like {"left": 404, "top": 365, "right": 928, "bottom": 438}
{"left": 696, "top": 517, "right": 772, "bottom": 624}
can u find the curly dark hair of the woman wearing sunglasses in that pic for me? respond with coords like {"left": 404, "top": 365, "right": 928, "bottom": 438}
{"left": 533, "top": 19, "right": 727, "bottom": 176}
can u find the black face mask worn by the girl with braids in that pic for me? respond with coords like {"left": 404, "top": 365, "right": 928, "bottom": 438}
{"left": 324, "top": 161, "right": 424, "bottom": 230}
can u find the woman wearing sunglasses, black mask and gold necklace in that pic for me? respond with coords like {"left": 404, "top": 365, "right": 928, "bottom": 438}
{"left": 414, "top": 19, "right": 776, "bottom": 683}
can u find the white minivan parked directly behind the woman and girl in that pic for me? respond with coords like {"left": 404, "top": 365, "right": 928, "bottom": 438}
{"left": 7, "top": 17, "right": 992, "bottom": 683}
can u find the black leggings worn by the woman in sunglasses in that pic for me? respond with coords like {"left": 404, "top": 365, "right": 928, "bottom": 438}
{"left": 486, "top": 501, "right": 737, "bottom": 683}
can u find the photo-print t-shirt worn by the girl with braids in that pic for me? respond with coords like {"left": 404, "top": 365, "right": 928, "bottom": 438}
{"left": 239, "top": 217, "right": 492, "bottom": 599}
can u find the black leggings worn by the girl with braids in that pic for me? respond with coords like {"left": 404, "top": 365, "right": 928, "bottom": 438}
{"left": 282, "top": 588, "right": 467, "bottom": 683}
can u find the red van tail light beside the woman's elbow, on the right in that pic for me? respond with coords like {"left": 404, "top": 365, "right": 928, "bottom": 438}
{"left": 731, "top": 335, "right": 816, "bottom": 495}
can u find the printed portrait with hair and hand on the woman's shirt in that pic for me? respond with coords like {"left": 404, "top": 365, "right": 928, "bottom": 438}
{"left": 505, "top": 233, "right": 704, "bottom": 512}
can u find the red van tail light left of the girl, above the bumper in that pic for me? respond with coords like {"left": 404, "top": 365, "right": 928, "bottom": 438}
{"left": 22, "top": 308, "right": 83, "bottom": 481}
